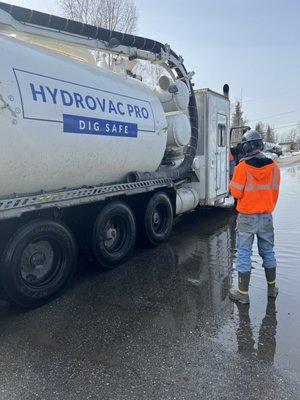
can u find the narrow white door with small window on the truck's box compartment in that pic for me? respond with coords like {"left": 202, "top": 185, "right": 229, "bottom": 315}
{"left": 215, "top": 113, "right": 229, "bottom": 197}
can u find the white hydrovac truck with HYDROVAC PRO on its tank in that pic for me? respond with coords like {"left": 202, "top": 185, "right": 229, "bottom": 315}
{"left": 0, "top": 2, "right": 230, "bottom": 308}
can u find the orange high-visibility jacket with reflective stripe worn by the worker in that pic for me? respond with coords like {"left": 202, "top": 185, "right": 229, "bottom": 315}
{"left": 230, "top": 161, "right": 280, "bottom": 214}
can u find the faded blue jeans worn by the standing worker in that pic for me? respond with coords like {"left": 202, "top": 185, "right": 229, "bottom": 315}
{"left": 236, "top": 214, "right": 277, "bottom": 273}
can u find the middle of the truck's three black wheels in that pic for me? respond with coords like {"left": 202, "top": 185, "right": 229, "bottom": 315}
{"left": 93, "top": 202, "right": 136, "bottom": 269}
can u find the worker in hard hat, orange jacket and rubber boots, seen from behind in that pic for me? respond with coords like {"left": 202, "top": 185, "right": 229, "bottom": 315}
{"left": 229, "top": 130, "right": 280, "bottom": 304}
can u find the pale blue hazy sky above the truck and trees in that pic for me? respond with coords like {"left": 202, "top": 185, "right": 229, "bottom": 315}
{"left": 2, "top": 0, "right": 300, "bottom": 135}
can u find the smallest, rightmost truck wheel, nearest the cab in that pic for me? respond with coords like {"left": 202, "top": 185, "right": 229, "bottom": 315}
{"left": 143, "top": 192, "right": 173, "bottom": 246}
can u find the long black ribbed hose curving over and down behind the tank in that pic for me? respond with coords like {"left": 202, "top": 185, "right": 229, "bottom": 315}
{"left": 0, "top": 2, "right": 198, "bottom": 180}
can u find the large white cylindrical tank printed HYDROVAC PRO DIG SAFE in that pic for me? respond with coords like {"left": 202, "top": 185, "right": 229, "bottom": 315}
{"left": 0, "top": 35, "right": 167, "bottom": 197}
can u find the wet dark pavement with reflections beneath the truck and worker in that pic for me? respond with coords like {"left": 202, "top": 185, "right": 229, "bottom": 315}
{"left": 0, "top": 165, "right": 300, "bottom": 400}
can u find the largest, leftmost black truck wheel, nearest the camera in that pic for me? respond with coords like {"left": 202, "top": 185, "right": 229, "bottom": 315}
{"left": 0, "top": 220, "right": 77, "bottom": 308}
